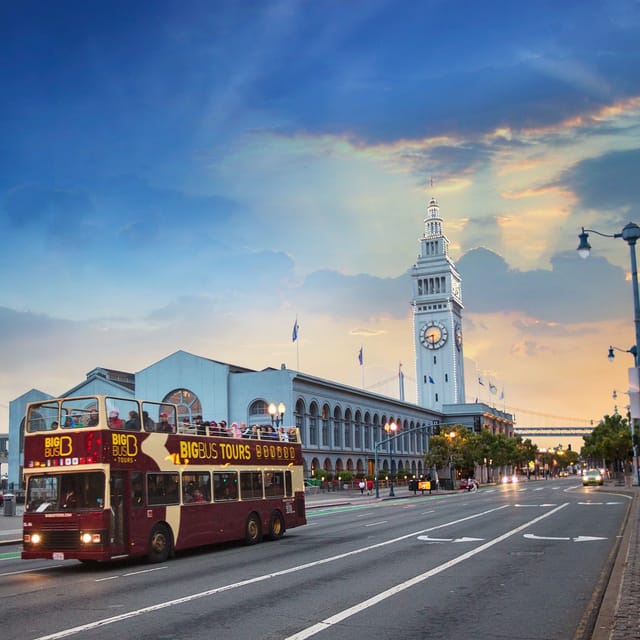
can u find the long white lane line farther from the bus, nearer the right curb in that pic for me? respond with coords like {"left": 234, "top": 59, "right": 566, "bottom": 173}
{"left": 286, "top": 502, "right": 569, "bottom": 640}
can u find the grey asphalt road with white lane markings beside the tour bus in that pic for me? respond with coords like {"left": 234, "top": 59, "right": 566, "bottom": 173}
{"left": 0, "top": 478, "right": 629, "bottom": 640}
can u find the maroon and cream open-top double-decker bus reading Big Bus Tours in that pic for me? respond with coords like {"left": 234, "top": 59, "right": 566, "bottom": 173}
{"left": 22, "top": 395, "right": 306, "bottom": 562}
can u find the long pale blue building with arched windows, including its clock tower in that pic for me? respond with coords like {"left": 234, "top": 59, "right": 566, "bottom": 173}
{"left": 8, "top": 199, "right": 514, "bottom": 491}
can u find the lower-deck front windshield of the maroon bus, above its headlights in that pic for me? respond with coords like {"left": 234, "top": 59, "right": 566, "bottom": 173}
{"left": 25, "top": 471, "right": 105, "bottom": 513}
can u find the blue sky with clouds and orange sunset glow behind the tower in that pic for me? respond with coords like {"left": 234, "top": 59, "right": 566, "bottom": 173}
{"left": 0, "top": 0, "right": 640, "bottom": 450}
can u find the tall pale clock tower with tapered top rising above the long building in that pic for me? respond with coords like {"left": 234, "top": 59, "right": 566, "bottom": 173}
{"left": 411, "top": 198, "right": 465, "bottom": 411}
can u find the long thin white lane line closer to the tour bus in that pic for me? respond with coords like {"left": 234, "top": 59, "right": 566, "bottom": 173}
{"left": 34, "top": 505, "right": 510, "bottom": 640}
